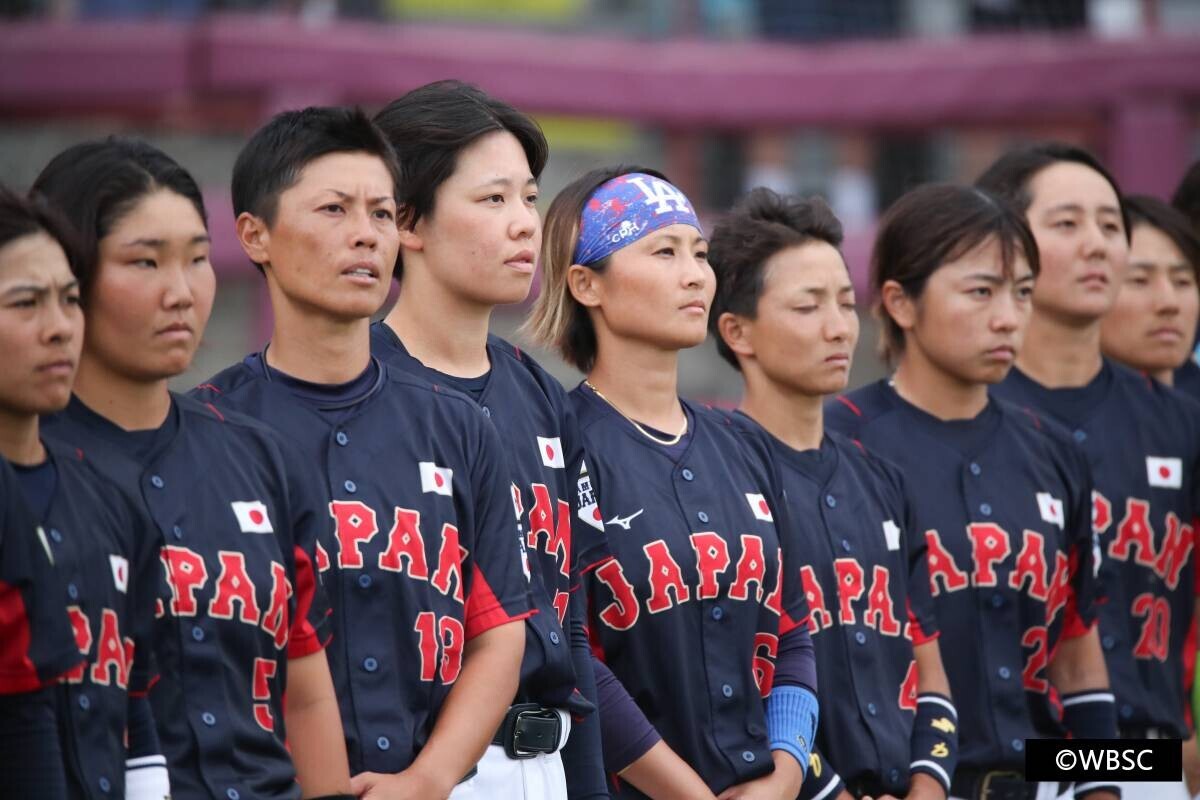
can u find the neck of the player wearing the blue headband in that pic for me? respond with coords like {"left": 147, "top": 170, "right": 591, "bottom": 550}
{"left": 588, "top": 341, "right": 686, "bottom": 434}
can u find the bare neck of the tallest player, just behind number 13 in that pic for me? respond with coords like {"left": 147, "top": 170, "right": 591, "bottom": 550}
{"left": 384, "top": 270, "right": 492, "bottom": 378}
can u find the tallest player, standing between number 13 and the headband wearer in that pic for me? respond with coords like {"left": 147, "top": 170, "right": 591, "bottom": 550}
{"left": 372, "top": 80, "right": 608, "bottom": 800}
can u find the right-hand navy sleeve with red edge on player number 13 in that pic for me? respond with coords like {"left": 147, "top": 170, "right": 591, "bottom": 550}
{"left": 463, "top": 417, "right": 533, "bottom": 640}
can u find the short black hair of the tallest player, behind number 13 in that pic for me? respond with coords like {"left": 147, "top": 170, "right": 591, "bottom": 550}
{"left": 374, "top": 80, "right": 550, "bottom": 279}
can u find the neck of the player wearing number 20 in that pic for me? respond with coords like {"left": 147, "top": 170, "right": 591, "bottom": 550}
{"left": 1016, "top": 309, "right": 1104, "bottom": 389}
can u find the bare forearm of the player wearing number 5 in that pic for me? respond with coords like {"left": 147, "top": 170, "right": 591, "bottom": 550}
{"left": 283, "top": 650, "right": 350, "bottom": 798}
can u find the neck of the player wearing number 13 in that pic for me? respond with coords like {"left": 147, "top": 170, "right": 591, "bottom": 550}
{"left": 266, "top": 293, "right": 371, "bottom": 384}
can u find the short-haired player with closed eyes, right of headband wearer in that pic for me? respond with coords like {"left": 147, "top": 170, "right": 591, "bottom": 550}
{"left": 708, "top": 188, "right": 959, "bottom": 799}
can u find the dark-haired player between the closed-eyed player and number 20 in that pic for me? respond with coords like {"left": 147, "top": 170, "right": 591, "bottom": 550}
{"left": 826, "top": 185, "right": 1116, "bottom": 800}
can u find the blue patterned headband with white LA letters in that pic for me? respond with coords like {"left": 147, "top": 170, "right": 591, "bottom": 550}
{"left": 571, "top": 173, "right": 704, "bottom": 265}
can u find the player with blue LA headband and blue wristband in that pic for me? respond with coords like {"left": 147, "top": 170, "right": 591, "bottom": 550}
{"left": 530, "top": 168, "right": 817, "bottom": 798}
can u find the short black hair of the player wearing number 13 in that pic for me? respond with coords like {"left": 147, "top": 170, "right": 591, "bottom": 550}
{"left": 233, "top": 106, "right": 400, "bottom": 235}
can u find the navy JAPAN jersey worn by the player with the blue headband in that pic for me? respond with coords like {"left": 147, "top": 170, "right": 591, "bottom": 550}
{"left": 570, "top": 385, "right": 806, "bottom": 798}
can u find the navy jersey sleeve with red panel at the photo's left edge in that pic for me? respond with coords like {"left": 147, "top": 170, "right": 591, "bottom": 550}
{"left": 0, "top": 458, "right": 83, "bottom": 694}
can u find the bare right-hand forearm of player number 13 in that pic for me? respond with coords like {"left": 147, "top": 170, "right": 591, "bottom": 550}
{"left": 409, "top": 620, "right": 524, "bottom": 794}
